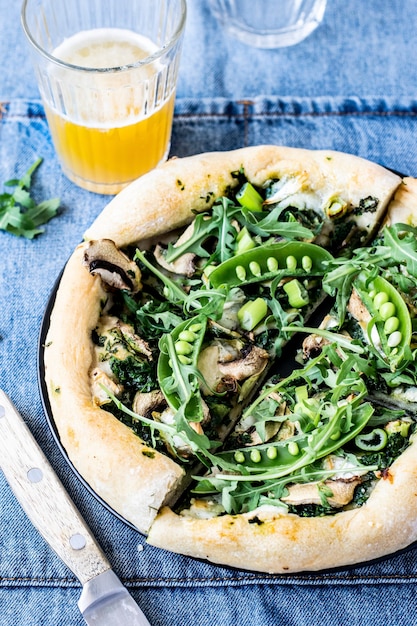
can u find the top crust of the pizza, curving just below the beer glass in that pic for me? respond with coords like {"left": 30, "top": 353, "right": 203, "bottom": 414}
{"left": 84, "top": 146, "right": 401, "bottom": 247}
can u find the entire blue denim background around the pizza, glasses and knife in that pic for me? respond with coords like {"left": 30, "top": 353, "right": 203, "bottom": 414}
{"left": 0, "top": 0, "right": 417, "bottom": 626}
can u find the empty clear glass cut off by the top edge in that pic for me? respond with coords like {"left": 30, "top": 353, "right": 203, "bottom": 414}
{"left": 210, "top": 0, "right": 327, "bottom": 48}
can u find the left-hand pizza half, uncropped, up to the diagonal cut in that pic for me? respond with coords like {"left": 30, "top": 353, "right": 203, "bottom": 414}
{"left": 45, "top": 146, "right": 401, "bottom": 532}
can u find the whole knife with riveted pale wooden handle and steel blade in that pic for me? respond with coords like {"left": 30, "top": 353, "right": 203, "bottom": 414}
{"left": 0, "top": 390, "right": 150, "bottom": 626}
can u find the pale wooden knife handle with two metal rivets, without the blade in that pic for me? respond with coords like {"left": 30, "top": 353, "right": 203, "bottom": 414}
{"left": 0, "top": 390, "right": 110, "bottom": 585}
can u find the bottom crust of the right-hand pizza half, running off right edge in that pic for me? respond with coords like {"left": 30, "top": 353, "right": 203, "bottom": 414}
{"left": 148, "top": 441, "right": 417, "bottom": 574}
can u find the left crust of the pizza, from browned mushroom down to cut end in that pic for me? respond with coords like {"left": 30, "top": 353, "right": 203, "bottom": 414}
{"left": 45, "top": 244, "right": 184, "bottom": 532}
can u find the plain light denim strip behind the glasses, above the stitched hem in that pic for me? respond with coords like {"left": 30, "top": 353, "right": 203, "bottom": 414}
{"left": 0, "top": 0, "right": 417, "bottom": 100}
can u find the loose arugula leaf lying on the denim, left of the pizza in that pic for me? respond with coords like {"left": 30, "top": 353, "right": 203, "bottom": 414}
{"left": 0, "top": 158, "right": 60, "bottom": 239}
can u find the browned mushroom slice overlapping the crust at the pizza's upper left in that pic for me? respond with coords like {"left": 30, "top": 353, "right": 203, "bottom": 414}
{"left": 84, "top": 239, "right": 142, "bottom": 293}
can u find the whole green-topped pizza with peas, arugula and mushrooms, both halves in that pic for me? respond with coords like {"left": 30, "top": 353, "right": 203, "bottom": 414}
{"left": 44, "top": 146, "right": 417, "bottom": 573}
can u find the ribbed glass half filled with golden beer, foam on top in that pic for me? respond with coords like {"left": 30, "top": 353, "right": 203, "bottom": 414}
{"left": 22, "top": 0, "right": 186, "bottom": 194}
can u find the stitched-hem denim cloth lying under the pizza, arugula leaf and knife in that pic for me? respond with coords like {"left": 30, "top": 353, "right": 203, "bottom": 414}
{"left": 0, "top": 92, "right": 417, "bottom": 626}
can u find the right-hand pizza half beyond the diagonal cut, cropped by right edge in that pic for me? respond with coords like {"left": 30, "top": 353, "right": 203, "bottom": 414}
{"left": 148, "top": 208, "right": 417, "bottom": 572}
